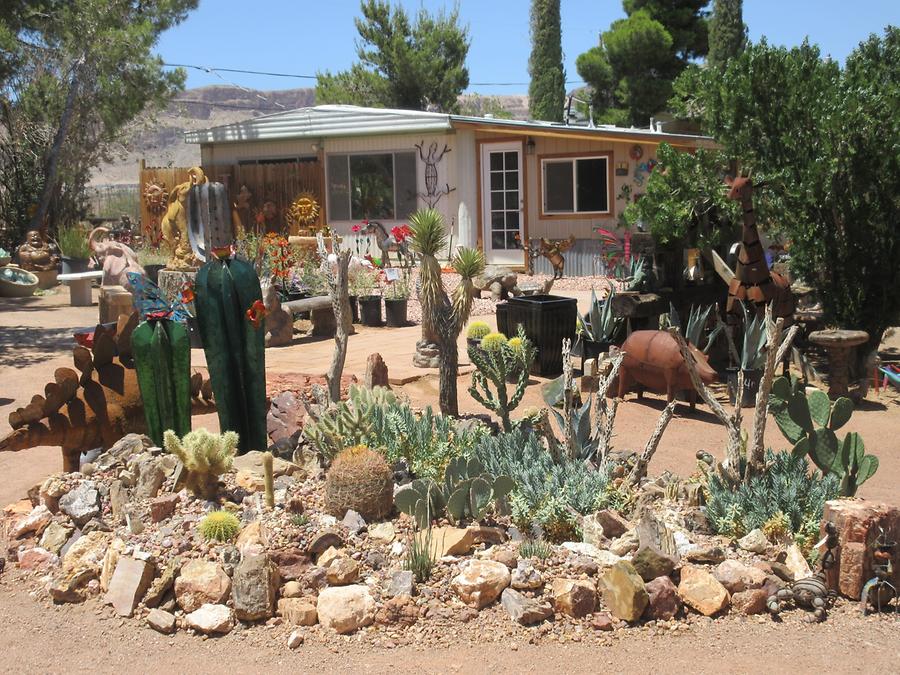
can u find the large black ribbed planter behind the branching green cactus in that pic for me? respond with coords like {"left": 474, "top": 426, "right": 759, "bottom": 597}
{"left": 497, "top": 295, "right": 578, "bottom": 377}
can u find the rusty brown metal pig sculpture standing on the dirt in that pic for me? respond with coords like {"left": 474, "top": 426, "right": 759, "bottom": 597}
{"left": 618, "top": 330, "right": 716, "bottom": 408}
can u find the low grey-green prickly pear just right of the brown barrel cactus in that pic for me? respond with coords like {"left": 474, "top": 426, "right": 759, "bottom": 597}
{"left": 394, "top": 457, "right": 515, "bottom": 528}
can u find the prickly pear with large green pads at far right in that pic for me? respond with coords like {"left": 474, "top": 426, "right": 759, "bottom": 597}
{"left": 769, "top": 377, "right": 878, "bottom": 497}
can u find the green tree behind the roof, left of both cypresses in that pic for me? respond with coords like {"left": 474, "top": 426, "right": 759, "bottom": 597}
{"left": 316, "top": 0, "right": 469, "bottom": 112}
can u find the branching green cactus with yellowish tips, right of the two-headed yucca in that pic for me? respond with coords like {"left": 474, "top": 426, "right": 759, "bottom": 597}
{"left": 468, "top": 326, "right": 536, "bottom": 432}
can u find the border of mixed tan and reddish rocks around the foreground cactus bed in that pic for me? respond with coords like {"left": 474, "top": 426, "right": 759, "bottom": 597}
{"left": 3, "top": 435, "right": 900, "bottom": 647}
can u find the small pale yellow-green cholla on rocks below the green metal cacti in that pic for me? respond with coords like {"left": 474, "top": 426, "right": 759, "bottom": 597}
{"left": 163, "top": 429, "right": 238, "bottom": 499}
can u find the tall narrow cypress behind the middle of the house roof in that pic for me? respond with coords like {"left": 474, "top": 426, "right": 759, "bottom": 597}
{"left": 528, "top": 0, "right": 566, "bottom": 122}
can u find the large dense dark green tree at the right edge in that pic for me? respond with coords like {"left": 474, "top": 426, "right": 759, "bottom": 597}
{"left": 673, "top": 26, "right": 900, "bottom": 345}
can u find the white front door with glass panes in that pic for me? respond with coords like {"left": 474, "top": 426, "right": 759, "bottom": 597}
{"left": 481, "top": 142, "right": 525, "bottom": 265}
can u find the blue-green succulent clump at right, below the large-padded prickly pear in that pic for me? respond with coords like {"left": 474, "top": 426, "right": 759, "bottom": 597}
{"left": 706, "top": 449, "right": 839, "bottom": 547}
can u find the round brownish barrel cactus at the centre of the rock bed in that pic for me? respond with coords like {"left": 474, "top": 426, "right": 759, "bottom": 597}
{"left": 325, "top": 445, "right": 394, "bottom": 521}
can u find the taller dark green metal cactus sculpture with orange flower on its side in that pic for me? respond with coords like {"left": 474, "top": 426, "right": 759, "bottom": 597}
{"left": 195, "top": 256, "right": 268, "bottom": 454}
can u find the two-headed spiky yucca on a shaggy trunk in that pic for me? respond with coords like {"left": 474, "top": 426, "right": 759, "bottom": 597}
{"left": 409, "top": 209, "right": 484, "bottom": 415}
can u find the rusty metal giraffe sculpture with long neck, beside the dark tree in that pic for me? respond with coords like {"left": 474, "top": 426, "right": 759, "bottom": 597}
{"left": 725, "top": 176, "right": 796, "bottom": 326}
